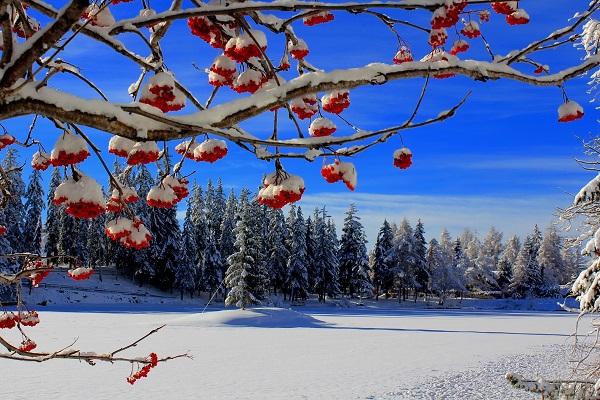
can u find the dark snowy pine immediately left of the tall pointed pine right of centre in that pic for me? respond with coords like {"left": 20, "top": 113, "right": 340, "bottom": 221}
{"left": 313, "top": 207, "right": 340, "bottom": 303}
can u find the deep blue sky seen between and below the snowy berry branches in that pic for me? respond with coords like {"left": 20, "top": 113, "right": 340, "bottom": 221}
{"left": 5, "top": 0, "right": 597, "bottom": 241}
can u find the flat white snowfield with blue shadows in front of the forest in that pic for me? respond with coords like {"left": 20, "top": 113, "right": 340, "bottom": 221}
{"left": 0, "top": 304, "right": 576, "bottom": 400}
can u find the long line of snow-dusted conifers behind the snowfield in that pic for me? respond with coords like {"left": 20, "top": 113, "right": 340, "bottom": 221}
{"left": 0, "top": 149, "right": 581, "bottom": 307}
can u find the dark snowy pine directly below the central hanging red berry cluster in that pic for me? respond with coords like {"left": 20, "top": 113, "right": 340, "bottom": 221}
{"left": 267, "top": 209, "right": 292, "bottom": 294}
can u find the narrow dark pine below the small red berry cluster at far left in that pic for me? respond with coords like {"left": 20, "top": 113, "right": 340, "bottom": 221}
{"left": 22, "top": 169, "right": 45, "bottom": 254}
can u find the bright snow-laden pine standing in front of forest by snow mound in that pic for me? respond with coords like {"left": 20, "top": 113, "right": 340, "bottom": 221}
{"left": 225, "top": 197, "right": 264, "bottom": 309}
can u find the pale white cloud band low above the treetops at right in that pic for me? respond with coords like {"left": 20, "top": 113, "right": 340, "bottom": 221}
{"left": 300, "top": 193, "right": 570, "bottom": 245}
